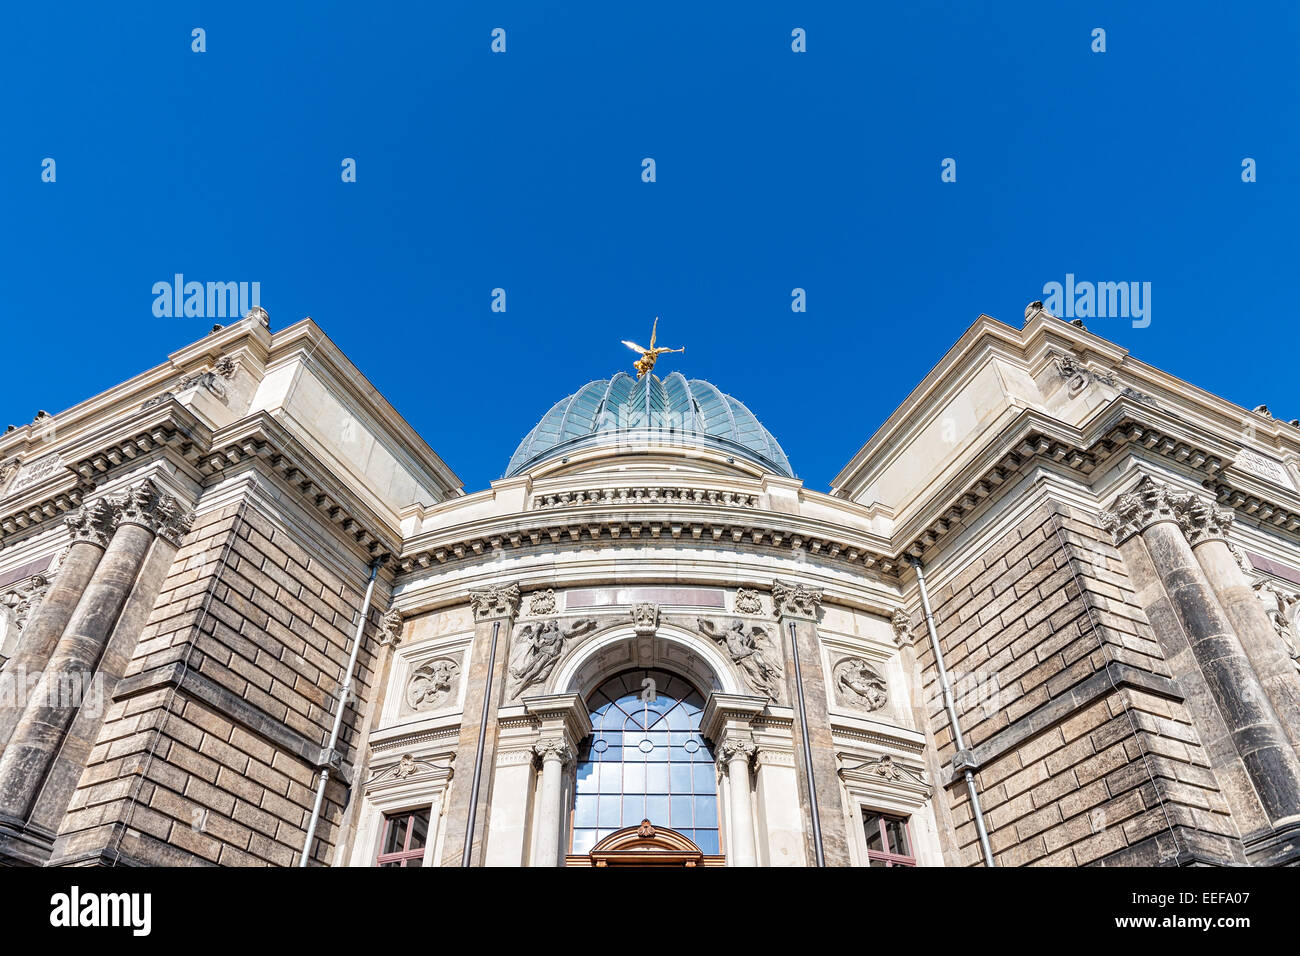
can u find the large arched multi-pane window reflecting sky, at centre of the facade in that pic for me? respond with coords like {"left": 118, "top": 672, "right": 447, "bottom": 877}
{"left": 572, "top": 670, "right": 719, "bottom": 853}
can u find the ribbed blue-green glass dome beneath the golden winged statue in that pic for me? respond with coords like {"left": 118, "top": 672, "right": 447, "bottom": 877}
{"left": 506, "top": 372, "right": 794, "bottom": 477}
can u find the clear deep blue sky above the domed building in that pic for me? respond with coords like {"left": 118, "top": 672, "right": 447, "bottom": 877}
{"left": 0, "top": 1, "right": 1300, "bottom": 490}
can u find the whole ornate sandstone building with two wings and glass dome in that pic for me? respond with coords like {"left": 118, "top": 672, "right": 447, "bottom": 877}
{"left": 0, "top": 303, "right": 1300, "bottom": 866}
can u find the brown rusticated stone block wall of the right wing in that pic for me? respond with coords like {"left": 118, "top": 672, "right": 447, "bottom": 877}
{"left": 917, "top": 501, "right": 1244, "bottom": 866}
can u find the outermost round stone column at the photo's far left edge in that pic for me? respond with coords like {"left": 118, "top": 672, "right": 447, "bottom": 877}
{"left": 0, "top": 498, "right": 117, "bottom": 750}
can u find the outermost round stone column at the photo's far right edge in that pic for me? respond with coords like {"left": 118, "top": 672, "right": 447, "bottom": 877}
{"left": 1179, "top": 496, "right": 1300, "bottom": 752}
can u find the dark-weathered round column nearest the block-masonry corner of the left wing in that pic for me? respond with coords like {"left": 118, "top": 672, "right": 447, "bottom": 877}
{"left": 0, "top": 480, "right": 192, "bottom": 822}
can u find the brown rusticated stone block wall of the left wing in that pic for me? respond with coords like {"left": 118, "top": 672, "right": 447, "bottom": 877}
{"left": 51, "top": 498, "right": 385, "bottom": 866}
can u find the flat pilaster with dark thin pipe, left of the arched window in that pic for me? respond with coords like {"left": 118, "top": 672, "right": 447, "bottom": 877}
{"left": 442, "top": 584, "right": 519, "bottom": 866}
